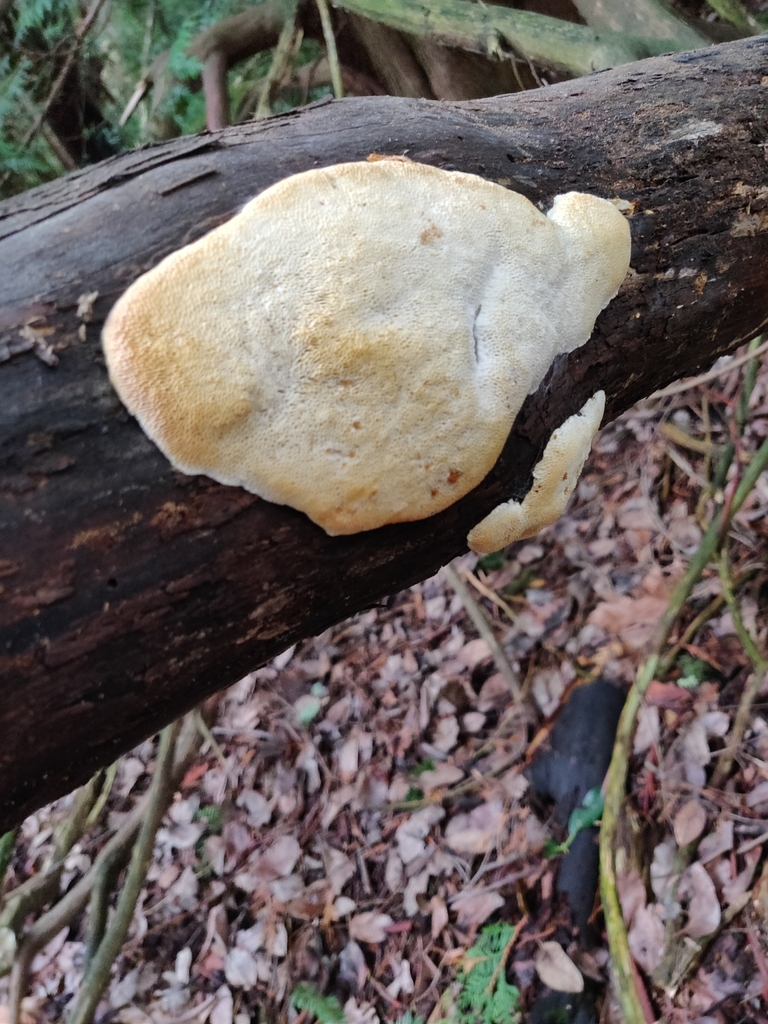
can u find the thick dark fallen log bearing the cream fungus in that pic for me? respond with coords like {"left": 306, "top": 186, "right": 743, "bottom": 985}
{"left": 0, "top": 38, "right": 768, "bottom": 829}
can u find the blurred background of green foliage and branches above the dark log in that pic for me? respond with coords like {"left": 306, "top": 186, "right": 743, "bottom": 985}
{"left": 0, "top": 0, "right": 768, "bottom": 198}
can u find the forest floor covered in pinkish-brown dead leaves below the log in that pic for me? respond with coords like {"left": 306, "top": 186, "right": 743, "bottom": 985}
{"left": 0, "top": 346, "right": 768, "bottom": 1024}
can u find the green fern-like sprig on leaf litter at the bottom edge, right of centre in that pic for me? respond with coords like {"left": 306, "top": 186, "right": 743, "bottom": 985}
{"left": 456, "top": 922, "right": 520, "bottom": 1024}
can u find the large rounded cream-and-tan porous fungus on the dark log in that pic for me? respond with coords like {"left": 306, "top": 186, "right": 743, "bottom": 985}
{"left": 103, "top": 160, "right": 630, "bottom": 534}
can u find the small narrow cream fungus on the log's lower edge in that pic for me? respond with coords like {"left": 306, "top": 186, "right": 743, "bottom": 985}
{"left": 467, "top": 391, "right": 605, "bottom": 555}
